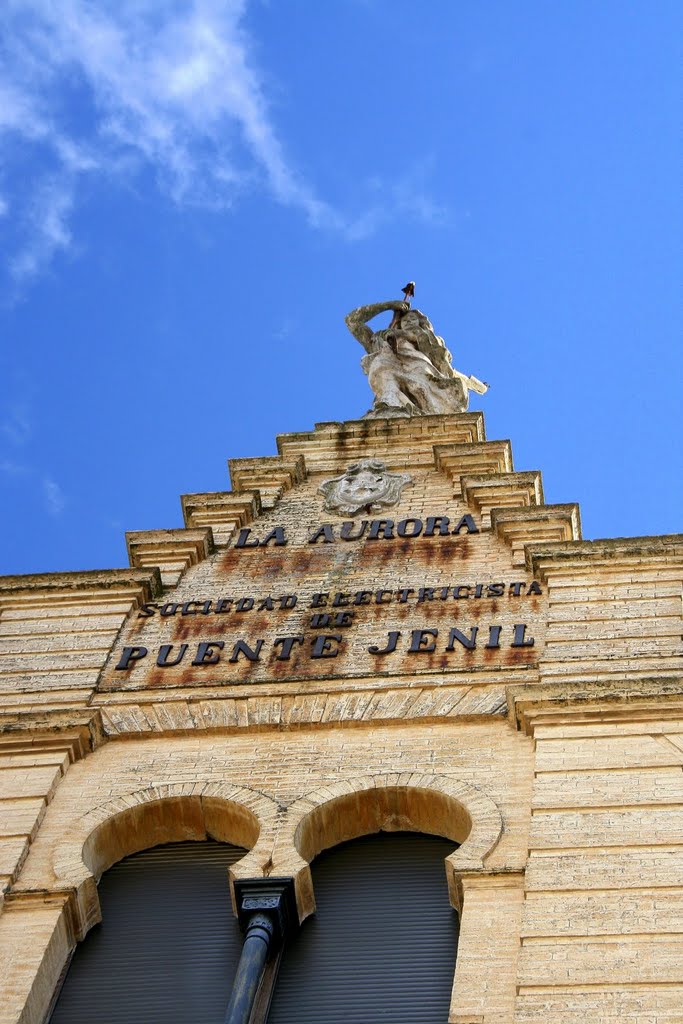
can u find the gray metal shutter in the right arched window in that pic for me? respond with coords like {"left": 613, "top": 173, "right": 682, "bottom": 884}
{"left": 268, "top": 833, "right": 458, "bottom": 1024}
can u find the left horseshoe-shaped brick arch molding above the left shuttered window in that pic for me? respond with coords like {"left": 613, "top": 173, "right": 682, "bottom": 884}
{"left": 52, "top": 782, "right": 281, "bottom": 941}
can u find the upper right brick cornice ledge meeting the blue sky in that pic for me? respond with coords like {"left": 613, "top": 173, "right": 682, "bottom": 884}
{"left": 524, "top": 534, "right": 683, "bottom": 577}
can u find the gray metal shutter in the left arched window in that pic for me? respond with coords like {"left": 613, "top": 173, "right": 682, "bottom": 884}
{"left": 51, "top": 840, "right": 245, "bottom": 1024}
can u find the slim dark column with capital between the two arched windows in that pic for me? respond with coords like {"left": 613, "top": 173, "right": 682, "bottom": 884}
{"left": 224, "top": 879, "right": 299, "bottom": 1024}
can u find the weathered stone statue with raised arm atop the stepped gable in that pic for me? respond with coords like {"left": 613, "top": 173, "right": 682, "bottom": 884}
{"left": 346, "top": 292, "right": 488, "bottom": 417}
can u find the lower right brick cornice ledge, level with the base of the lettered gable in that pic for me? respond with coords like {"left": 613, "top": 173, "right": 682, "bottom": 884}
{"left": 506, "top": 676, "right": 683, "bottom": 735}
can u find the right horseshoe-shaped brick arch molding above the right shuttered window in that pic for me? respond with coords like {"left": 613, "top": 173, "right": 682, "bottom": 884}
{"left": 272, "top": 773, "right": 503, "bottom": 920}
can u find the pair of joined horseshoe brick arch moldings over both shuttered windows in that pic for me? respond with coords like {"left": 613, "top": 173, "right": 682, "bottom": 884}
{"left": 52, "top": 773, "right": 503, "bottom": 940}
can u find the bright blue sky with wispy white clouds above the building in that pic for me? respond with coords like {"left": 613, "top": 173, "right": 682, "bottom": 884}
{"left": 0, "top": 0, "right": 683, "bottom": 572}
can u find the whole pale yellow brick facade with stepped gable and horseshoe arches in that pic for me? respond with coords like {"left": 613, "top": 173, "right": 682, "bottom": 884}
{"left": 0, "top": 414, "right": 683, "bottom": 1024}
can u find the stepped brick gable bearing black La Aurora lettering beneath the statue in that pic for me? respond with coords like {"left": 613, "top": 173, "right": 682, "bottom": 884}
{"left": 92, "top": 413, "right": 578, "bottom": 708}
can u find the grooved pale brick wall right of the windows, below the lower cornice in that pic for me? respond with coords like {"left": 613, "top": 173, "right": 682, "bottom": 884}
{"left": 516, "top": 689, "right": 683, "bottom": 1022}
